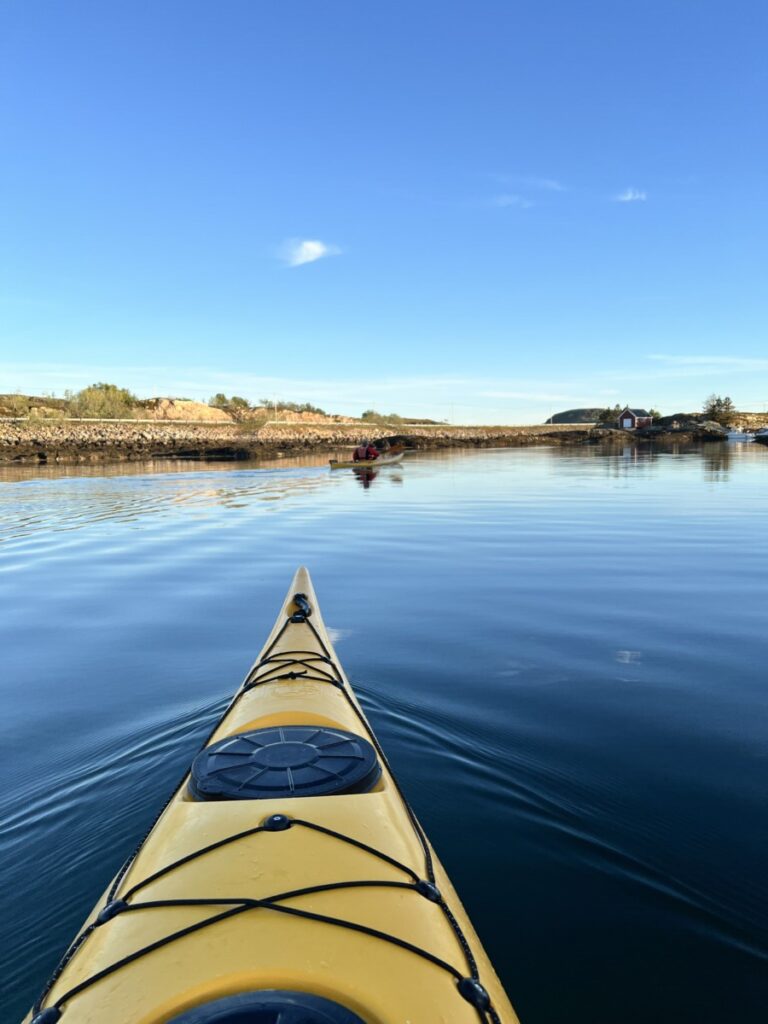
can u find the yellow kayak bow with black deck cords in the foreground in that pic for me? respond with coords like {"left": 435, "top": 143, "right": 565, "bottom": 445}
{"left": 25, "top": 568, "right": 517, "bottom": 1024}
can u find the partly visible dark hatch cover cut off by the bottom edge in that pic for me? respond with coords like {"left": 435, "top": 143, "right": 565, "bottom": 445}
{"left": 170, "top": 989, "right": 362, "bottom": 1024}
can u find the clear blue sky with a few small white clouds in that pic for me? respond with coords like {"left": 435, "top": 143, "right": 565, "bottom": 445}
{"left": 0, "top": 0, "right": 768, "bottom": 423}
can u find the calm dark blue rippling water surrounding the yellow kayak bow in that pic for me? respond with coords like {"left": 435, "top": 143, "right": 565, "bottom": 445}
{"left": 0, "top": 444, "right": 768, "bottom": 1024}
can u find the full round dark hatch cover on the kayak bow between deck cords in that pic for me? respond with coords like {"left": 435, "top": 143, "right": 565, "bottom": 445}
{"left": 190, "top": 725, "right": 381, "bottom": 800}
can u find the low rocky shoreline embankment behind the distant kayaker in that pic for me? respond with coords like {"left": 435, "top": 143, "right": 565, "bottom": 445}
{"left": 0, "top": 420, "right": 745, "bottom": 464}
